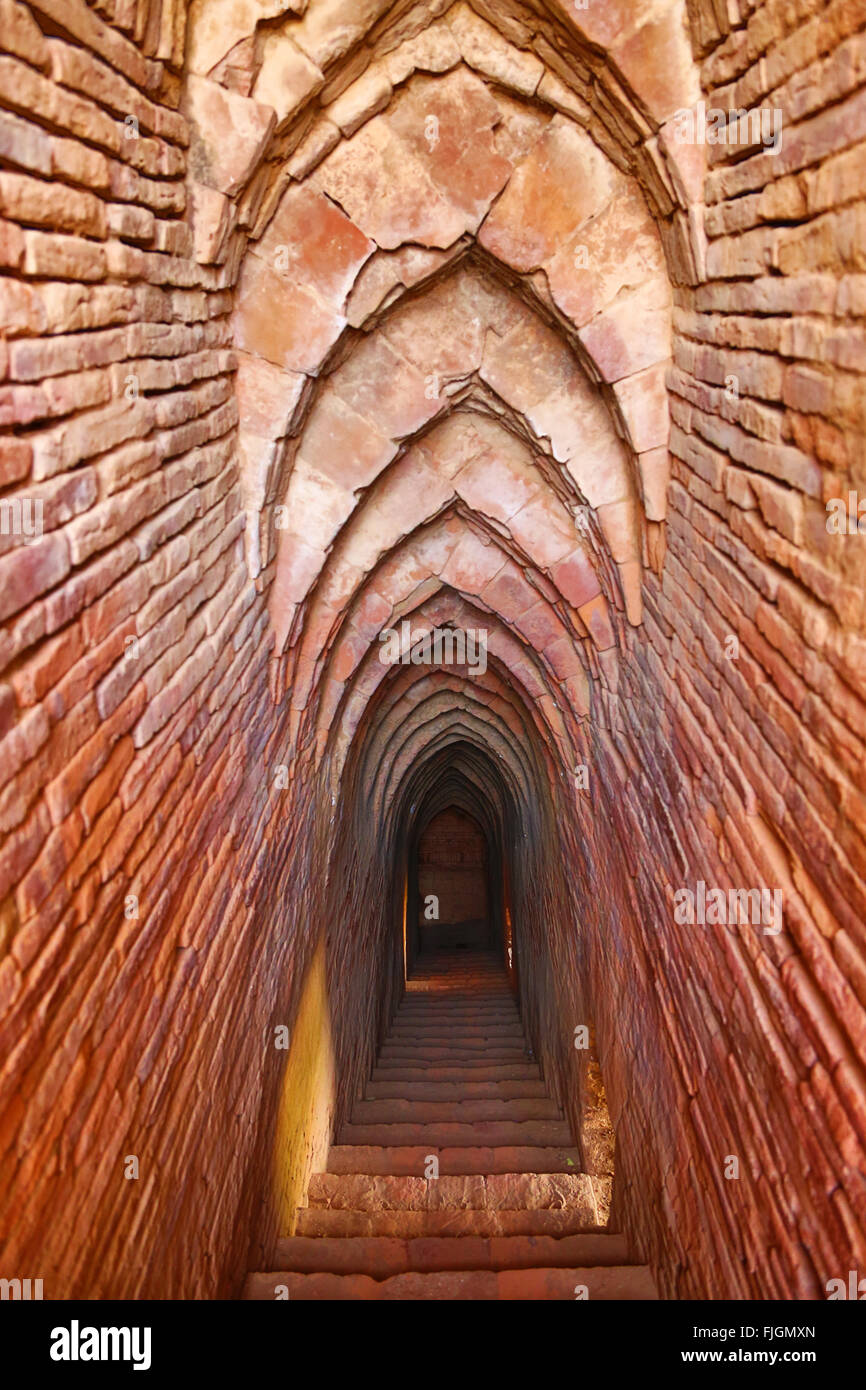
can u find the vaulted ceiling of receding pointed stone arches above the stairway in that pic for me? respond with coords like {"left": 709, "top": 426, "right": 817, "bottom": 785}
{"left": 185, "top": 0, "right": 702, "bottom": 834}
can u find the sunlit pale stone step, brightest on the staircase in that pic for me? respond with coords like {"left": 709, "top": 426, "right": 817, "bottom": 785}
{"left": 307, "top": 1173, "right": 603, "bottom": 1206}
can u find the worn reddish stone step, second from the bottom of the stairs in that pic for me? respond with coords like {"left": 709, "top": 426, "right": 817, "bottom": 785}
{"left": 277, "top": 1236, "right": 627, "bottom": 1279}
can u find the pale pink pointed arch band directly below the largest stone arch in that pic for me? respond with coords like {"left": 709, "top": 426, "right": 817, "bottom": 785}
{"left": 261, "top": 273, "right": 639, "bottom": 639}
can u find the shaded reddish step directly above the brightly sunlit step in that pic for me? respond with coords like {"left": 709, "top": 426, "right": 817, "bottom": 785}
{"left": 328, "top": 1144, "right": 581, "bottom": 1177}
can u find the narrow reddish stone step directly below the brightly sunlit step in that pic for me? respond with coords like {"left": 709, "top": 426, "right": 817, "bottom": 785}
{"left": 301, "top": 1207, "right": 614, "bottom": 1239}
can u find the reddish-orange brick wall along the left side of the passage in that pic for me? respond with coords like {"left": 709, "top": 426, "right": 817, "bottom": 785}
{"left": 0, "top": 0, "right": 297, "bottom": 1297}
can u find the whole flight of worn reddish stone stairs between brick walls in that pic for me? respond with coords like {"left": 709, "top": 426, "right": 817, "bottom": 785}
{"left": 245, "top": 951, "right": 656, "bottom": 1300}
